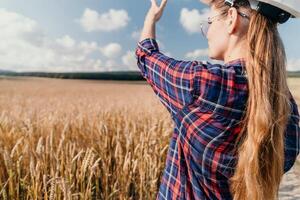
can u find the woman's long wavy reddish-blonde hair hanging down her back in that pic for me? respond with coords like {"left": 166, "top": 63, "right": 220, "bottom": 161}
{"left": 211, "top": 0, "right": 291, "bottom": 200}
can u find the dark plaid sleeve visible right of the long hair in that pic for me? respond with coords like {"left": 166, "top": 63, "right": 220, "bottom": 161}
{"left": 284, "top": 94, "right": 300, "bottom": 173}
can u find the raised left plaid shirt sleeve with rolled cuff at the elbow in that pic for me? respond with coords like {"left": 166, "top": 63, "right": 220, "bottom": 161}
{"left": 135, "top": 38, "right": 202, "bottom": 118}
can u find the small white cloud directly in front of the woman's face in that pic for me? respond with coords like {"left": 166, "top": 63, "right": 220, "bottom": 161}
{"left": 180, "top": 8, "right": 209, "bottom": 34}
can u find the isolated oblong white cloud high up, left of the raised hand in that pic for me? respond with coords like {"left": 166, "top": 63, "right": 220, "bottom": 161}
{"left": 79, "top": 8, "right": 130, "bottom": 32}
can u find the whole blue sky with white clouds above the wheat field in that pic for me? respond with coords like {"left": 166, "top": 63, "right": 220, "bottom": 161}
{"left": 0, "top": 0, "right": 300, "bottom": 71}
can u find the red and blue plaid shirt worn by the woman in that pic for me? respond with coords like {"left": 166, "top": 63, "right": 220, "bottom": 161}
{"left": 135, "top": 38, "right": 300, "bottom": 200}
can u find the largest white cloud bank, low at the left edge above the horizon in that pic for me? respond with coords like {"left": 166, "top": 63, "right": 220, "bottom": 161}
{"left": 0, "top": 9, "right": 102, "bottom": 71}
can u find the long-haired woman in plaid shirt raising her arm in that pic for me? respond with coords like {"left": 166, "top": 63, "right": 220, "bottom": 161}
{"left": 135, "top": 0, "right": 300, "bottom": 200}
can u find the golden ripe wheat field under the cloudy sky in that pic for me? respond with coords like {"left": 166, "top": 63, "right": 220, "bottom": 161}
{"left": 0, "top": 77, "right": 300, "bottom": 200}
